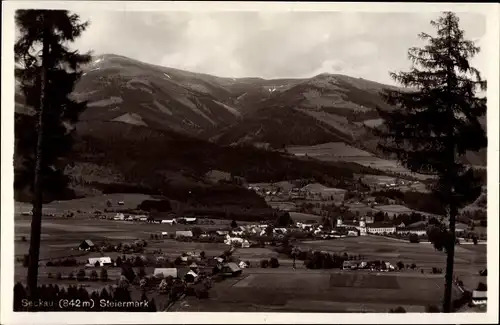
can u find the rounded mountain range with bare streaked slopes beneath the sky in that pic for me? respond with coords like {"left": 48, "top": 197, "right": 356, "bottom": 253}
{"left": 16, "top": 54, "right": 486, "bottom": 204}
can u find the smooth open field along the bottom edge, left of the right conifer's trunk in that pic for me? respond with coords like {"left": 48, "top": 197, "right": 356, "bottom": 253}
{"left": 176, "top": 268, "right": 460, "bottom": 312}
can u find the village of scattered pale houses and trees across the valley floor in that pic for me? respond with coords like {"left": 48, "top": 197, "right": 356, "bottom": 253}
{"left": 16, "top": 185, "right": 486, "bottom": 310}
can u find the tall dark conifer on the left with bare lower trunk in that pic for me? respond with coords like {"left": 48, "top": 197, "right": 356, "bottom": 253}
{"left": 14, "top": 9, "right": 90, "bottom": 297}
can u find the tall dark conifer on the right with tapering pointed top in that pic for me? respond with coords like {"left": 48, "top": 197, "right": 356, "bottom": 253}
{"left": 378, "top": 12, "right": 487, "bottom": 312}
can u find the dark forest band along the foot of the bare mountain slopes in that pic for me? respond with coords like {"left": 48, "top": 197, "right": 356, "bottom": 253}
{"left": 74, "top": 122, "right": 388, "bottom": 188}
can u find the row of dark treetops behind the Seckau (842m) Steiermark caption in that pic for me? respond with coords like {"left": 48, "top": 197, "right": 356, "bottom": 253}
{"left": 14, "top": 282, "right": 156, "bottom": 312}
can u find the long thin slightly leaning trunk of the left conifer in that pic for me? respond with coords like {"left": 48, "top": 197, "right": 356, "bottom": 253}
{"left": 27, "top": 14, "right": 50, "bottom": 299}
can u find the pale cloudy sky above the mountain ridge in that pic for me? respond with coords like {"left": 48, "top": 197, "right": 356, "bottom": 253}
{"left": 74, "top": 11, "right": 487, "bottom": 84}
